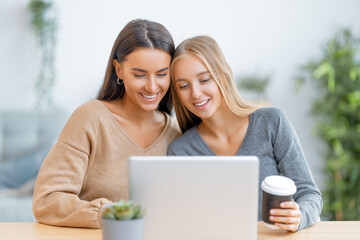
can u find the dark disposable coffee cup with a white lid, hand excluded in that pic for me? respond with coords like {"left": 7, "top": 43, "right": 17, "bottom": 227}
{"left": 261, "top": 176, "right": 296, "bottom": 229}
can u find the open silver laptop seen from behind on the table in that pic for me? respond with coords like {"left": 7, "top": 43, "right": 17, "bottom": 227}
{"left": 129, "top": 156, "right": 259, "bottom": 240}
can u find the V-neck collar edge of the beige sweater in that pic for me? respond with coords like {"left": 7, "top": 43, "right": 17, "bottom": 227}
{"left": 96, "top": 100, "right": 170, "bottom": 152}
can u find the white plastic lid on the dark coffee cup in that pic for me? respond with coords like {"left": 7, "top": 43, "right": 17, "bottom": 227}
{"left": 261, "top": 176, "right": 296, "bottom": 196}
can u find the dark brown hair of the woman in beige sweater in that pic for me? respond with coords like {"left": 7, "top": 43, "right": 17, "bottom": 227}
{"left": 97, "top": 19, "right": 175, "bottom": 114}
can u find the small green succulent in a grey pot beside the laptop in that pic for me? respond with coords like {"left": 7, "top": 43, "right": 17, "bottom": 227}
{"left": 102, "top": 200, "right": 145, "bottom": 240}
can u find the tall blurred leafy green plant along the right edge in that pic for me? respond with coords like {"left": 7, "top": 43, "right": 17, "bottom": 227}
{"left": 297, "top": 29, "right": 360, "bottom": 220}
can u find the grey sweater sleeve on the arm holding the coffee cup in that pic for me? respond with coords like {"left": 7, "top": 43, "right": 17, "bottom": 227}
{"left": 273, "top": 109, "right": 323, "bottom": 230}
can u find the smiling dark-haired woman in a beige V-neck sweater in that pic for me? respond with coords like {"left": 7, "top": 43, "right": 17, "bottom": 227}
{"left": 33, "top": 19, "right": 180, "bottom": 228}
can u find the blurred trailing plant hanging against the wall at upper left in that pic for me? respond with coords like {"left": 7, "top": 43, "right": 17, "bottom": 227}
{"left": 27, "top": 0, "right": 57, "bottom": 109}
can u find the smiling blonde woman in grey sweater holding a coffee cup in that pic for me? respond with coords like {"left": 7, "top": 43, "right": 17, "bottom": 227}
{"left": 168, "top": 36, "right": 322, "bottom": 232}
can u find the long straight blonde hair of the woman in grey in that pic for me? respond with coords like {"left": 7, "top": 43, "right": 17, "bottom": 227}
{"left": 170, "top": 36, "right": 259, "bottom": 133}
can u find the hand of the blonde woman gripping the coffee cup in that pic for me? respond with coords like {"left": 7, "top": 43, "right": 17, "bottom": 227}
{"left": 269, "top": 201, "right": 301, "bottom": 232}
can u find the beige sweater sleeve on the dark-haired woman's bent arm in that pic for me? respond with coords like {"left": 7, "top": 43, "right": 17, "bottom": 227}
{"left": 33, "top": 103, "right": 110, "bottom": 228}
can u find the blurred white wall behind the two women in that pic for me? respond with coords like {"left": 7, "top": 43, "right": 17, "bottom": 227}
{"left": 0, "top": 0, "right": 360, "bottom": 186}
